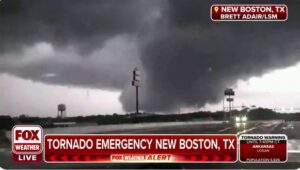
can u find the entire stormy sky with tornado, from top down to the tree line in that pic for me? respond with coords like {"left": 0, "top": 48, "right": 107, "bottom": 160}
{"left": 0, "top": 0, "right": 300, "bottom": 115}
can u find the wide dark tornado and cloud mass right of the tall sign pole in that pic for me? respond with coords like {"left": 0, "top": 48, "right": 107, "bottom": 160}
{"left": 121, "top": 0, "right": 300, "bottom": 111}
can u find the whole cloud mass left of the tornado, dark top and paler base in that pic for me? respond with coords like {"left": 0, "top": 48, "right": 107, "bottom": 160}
{"left": 0, "top": 0, "right": 162, "bottom": 89}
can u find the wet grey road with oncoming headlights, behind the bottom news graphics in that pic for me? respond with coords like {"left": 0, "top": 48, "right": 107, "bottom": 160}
{"left": 0, "top": 121, "right": 300, "bottom": 169}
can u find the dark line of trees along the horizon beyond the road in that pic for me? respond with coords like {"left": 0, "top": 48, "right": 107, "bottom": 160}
{"left": 0, "top": 108, "right": 300, "bottom": 130}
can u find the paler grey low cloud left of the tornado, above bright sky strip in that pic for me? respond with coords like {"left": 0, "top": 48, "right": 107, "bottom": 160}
{"left": 0, "top": 37, "right": 138, "bottom": 90}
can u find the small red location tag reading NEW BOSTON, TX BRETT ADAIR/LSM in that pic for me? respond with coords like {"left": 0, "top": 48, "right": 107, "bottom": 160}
{"left": 210, "top": 4, "right": 288, "bottom": 21}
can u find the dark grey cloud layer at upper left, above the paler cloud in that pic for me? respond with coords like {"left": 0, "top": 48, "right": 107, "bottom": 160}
{"left": 0, "top": 0, "right": 156, "bottom": 50}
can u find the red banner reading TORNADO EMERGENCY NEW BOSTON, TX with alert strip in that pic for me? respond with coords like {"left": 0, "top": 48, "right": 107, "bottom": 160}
{"left": 44, "top": 134, "right": 237, "bottom": 163}
